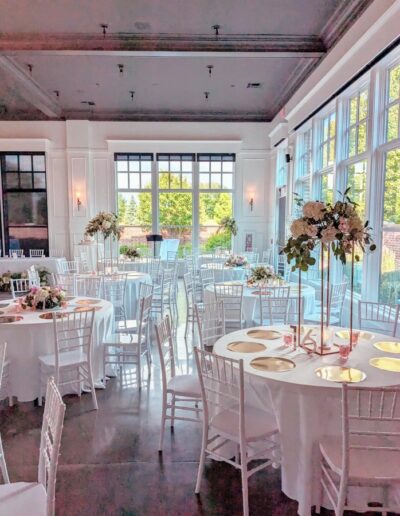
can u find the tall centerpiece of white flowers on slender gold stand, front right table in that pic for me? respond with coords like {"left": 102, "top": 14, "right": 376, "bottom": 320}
{"left": 282, "top": 189, "right": 376, "bottom": 354}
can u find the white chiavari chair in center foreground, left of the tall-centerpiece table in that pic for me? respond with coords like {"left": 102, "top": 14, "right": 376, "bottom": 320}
{"left": 195, "top": 348, "right": 279, "bottom": 516}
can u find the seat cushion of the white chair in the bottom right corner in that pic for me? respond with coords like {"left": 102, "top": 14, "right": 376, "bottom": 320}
{"left": 320, "top": 437, "right": 400, "bottom": 484}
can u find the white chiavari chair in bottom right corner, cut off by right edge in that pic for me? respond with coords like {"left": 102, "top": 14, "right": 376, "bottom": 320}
{"left": 316, "top": 384, "right": 400, "bottom": 516}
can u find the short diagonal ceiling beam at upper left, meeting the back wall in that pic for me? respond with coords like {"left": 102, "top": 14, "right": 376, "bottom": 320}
{"left": 0, "top": 56, "right": 62, "bottom": 118}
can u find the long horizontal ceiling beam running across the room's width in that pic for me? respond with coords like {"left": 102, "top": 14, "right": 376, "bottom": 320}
{"left": 0, "top": 33, "right": 326, "bottom": 57}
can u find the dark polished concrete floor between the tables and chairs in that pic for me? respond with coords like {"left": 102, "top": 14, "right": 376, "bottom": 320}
{"left": 0, "top": 288, "right": 390, "bottom": 516}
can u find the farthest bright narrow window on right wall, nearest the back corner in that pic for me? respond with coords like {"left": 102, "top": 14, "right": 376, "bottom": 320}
{"left": 294, "top": 129, "right": 312, "bottom": 217}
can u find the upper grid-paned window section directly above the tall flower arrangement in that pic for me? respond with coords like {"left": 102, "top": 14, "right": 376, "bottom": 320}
{"left": 346, "top": 89, "right": 368, "bottom": 158}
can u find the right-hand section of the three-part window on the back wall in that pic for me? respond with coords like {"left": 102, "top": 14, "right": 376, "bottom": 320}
{"left": 197, "top": 154, "right": 235, "bottom": 251}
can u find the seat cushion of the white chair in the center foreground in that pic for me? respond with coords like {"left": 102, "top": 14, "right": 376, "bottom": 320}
{"left": 210, "top": 405, "right": 278, "bottom": 441}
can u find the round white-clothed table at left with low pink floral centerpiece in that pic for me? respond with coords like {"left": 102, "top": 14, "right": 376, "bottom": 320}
{"left": 0, "top": 297, "right": 114, "bottom": 401}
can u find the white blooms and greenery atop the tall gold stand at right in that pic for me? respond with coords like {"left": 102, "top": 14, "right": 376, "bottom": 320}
{"left": 282, "top": 189, "right": 376, "bottom": 271}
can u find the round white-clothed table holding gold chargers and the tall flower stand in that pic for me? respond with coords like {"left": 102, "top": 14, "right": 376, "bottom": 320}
{"left": 214, "top": 326, "right": 400, "bottom": 516}
